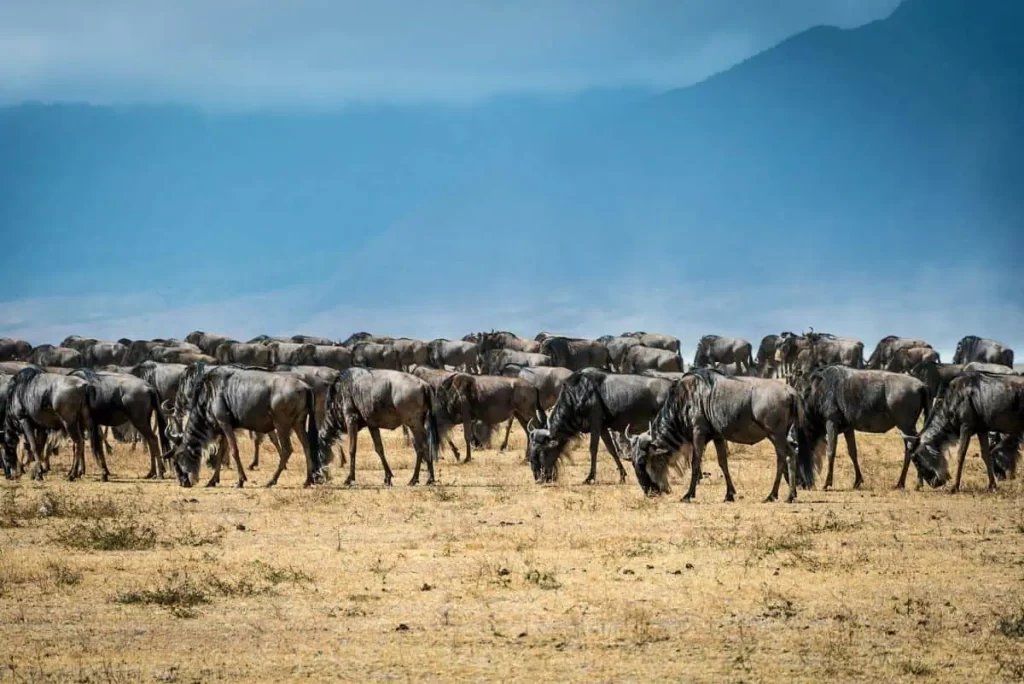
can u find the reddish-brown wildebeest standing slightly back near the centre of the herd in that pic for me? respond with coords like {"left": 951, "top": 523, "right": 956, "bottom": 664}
{"left": 437, "top": 373, "right": 540, "bottom": 463}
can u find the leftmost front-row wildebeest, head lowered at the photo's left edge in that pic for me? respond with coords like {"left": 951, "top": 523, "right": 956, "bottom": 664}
{"left": 3, "top": 368, "right": 103, "bottom": 482}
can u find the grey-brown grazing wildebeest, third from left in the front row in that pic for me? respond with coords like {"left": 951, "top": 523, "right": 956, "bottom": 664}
{"left": 167, "top": 366, "right": 319, "bottom": 487}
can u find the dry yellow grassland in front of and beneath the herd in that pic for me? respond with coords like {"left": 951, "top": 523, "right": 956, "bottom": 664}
{"left": 0, "top": 423, "right": 1024, "bottom": 682}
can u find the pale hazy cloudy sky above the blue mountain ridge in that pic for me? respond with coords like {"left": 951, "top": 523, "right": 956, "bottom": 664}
{"left": 0, "top": 0, "right": 899, "bottom": 106}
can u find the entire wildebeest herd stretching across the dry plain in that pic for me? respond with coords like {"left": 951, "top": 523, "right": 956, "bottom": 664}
{"left": 0, "top": 330, "right": 1024, "bottom": 501}
